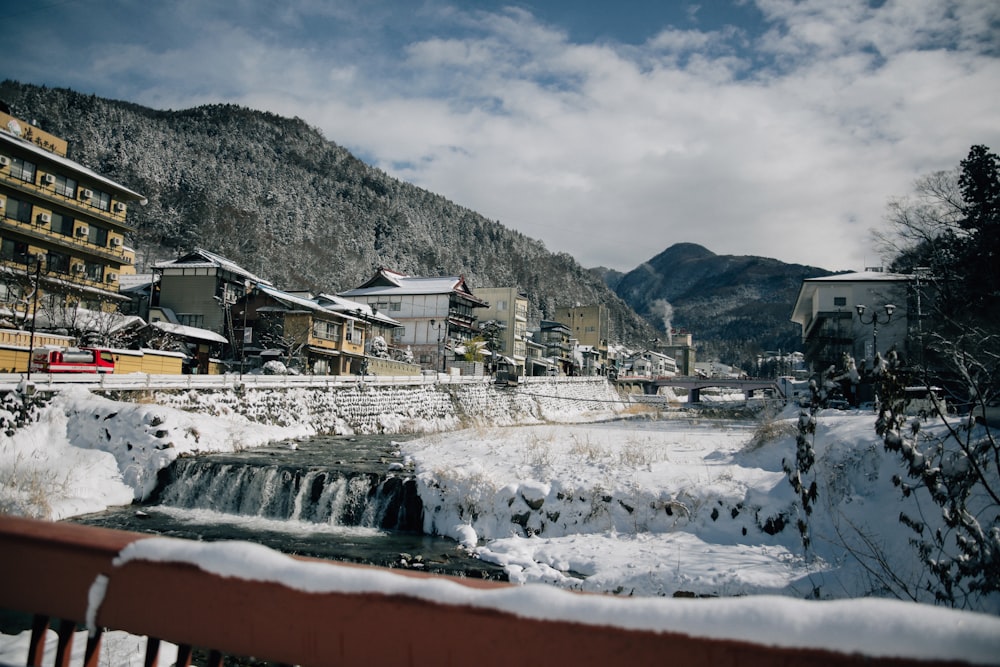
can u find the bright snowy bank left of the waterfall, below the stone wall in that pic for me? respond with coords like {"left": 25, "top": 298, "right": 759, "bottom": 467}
{"left": 0, "top": 387, "right": 310, "bottom": 520}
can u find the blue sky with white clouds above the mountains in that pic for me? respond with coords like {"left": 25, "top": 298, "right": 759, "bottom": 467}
{"left": 0, "top": 0, "right": 1000, "bottom": 271}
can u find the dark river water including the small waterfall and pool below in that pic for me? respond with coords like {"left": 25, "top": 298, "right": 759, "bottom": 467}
{"left": 72, "top": 435, "right": 505, "bottom": 579}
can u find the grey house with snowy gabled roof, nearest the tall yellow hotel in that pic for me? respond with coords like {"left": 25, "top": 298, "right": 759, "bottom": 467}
{"left": 152, "top": 248, "right": 271, "bottom": 340}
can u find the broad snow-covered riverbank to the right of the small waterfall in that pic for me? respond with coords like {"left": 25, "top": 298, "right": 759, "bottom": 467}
{"left": 401, "top": 409, "right": 1000, "bottom": 613}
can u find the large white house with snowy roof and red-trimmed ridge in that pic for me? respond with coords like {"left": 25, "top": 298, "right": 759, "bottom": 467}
{"left": 339, "top": 268, "right": 486, "bottom": 371}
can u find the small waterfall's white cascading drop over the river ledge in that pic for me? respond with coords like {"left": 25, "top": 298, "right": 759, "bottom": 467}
{"left": 157, "top": 457, "right": 423, "bottom": 532}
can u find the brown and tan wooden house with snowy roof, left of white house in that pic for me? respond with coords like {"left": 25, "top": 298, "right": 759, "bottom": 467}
{"left": 231, "top": 283, "right": 367, "bottom": 375}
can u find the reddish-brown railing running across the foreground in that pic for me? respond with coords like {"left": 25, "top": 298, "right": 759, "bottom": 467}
{"left": 0, "top": 515, "right": 984, "bottom": 667}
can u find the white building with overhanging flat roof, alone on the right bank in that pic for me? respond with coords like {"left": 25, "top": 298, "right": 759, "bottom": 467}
{"left": 790, "top": 269, "right": 913, "bottom": 371}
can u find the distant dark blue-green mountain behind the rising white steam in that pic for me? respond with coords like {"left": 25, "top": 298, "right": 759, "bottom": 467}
{"left": 612, "top": 243, "right": 831, "bottom": 371}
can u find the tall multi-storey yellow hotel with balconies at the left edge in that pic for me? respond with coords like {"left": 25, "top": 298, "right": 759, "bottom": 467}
{"left": 0, "top": 111, "right": 145, "bottom": 326}
